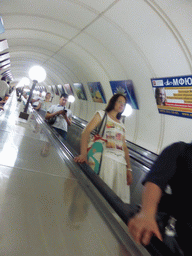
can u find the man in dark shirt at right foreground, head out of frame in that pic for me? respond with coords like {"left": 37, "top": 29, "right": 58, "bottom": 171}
{"left": 128, "top": 142, "right": 192, "bottom": 255}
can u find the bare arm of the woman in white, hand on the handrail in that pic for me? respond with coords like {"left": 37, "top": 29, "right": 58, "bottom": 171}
{"left": 74, "top": 113, "right": 101, "bottom": 163}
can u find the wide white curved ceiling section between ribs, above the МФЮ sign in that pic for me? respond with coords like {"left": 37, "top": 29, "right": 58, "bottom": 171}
{"left": 103, "top": 0, "right": 189, "bottom": 76}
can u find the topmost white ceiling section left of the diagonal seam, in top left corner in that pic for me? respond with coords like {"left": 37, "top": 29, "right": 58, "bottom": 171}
{"left": 1, "top": 0, "right": 96, "bottom": 28}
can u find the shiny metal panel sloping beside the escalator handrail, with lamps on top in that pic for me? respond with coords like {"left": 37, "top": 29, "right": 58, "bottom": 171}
{"left": 0, "top": 94, "right": 149, "bottom": 256}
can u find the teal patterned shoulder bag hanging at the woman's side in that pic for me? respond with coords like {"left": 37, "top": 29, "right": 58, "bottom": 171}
{"left": 87, "top": 112, "right": 107, "bottom": 175}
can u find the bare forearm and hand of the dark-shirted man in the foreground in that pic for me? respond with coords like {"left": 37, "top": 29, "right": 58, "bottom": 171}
{"left": 128, "top": 182, "right": 162, "bottom": 245}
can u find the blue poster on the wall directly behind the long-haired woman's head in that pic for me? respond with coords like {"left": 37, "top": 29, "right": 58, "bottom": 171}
{"left": 110, "top": 80, "right": 139, "bottom": 109}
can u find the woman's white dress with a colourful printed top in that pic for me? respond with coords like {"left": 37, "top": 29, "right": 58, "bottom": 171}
{"left": 97, "top": 110, "right": 130, "bottom": 204}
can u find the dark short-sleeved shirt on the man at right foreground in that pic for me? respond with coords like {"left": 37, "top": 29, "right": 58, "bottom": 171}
{"left": 143, "top": 142, "right": 192, "bottom": 255}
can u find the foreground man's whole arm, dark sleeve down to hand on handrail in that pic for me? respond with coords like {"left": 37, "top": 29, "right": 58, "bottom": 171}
{"left": 128, "top": 142, "right": 184, "bottom": 244}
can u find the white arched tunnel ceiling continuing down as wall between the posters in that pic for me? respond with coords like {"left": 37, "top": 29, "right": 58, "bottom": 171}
{"left": 0, "top": 0, "right": 192, "bottom": 152}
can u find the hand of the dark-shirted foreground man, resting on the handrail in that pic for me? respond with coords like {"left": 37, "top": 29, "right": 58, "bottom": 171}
{"left": 128, "top": 212, "right": 163, "bottom": 245}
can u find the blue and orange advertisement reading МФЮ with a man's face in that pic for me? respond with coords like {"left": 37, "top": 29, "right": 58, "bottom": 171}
{"left": 151, "top": 75, "right": 192, "bottom": 118}
